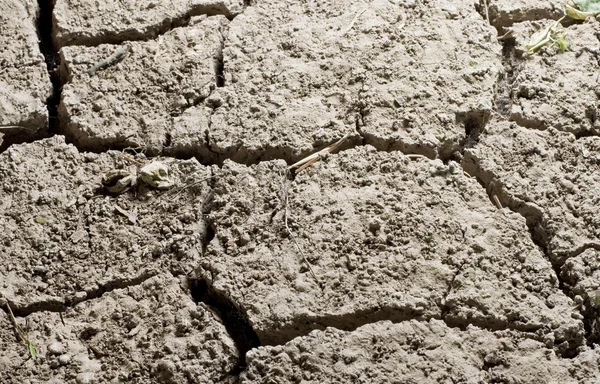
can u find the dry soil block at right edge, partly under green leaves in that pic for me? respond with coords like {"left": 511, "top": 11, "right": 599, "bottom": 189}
{"left": 509, "top": 20, "right": 600, "bottom": 136}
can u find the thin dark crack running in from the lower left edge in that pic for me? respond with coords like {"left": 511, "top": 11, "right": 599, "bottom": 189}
{"left": 2, "top": 272, "right": 156, "bottom": 317}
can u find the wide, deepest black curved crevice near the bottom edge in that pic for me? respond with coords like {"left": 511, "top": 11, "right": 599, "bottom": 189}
{"left": 190, "top": 279, "right": 261, "bottom": 375}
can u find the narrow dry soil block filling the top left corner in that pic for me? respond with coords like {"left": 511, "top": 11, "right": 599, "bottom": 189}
{"left": 0, "top": 0, "right": 52, "bottom": 148}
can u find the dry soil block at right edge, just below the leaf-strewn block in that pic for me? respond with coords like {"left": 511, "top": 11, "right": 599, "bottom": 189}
{"left": 463, "top": 122, "right": 600, "bottom": 265}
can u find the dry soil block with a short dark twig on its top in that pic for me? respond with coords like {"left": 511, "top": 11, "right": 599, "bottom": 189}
{"left": 59, "top": 16, "right": 228, "bottom": 155}
